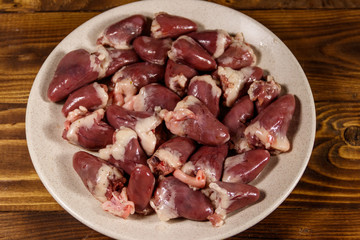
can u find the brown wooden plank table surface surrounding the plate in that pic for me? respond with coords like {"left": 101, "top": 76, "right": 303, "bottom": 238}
{"left": 0, "top": 0, "right": 360, "bottom": 239}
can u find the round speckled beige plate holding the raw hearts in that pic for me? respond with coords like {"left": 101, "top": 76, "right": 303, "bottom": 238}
{"left": 26, "top": 0, "right": 316, "bottom": 240}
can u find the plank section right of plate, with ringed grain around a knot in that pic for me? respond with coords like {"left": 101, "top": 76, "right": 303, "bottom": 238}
{"left": 284, "top": 102, "right": 360, "bottom": 208}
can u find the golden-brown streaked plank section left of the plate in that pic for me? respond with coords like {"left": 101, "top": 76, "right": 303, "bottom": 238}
{"left": 0, "top": 103, "right": 62, "bottom": 211}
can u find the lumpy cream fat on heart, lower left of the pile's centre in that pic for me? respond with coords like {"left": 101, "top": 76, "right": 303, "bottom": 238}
{"left": 99, "top": 127, "right": 137, "bottom": 161}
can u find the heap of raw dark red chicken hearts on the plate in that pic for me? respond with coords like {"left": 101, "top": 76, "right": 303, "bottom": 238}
{"left": 48, "top": 12, "right": 295, "bottom": 226}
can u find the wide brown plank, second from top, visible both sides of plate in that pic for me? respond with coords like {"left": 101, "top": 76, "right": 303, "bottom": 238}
{"left": 0, "top": 10, "right": 360, "bottom": 103}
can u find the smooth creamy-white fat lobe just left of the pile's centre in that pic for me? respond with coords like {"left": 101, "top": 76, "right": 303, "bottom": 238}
{"left": 135, "top": 114, "right": 162, "bottom": 156}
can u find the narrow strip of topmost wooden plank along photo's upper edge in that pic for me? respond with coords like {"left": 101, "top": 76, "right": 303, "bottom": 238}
{"left": 0, "top": 0, "right": 360, "bottom": 12}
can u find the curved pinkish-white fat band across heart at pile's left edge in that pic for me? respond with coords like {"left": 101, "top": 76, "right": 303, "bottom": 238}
{"left": 66, "top": 109, "right": 105, "bottom": 144}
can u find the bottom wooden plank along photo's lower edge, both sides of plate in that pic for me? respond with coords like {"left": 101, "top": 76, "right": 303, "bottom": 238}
{"left": 0, "top": 208, "right": 360, "bottom": 240}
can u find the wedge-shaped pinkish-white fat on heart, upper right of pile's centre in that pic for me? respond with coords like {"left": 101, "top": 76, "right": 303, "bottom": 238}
{"left": 218, "top": 66, "right": 247, "bottom": 107}
